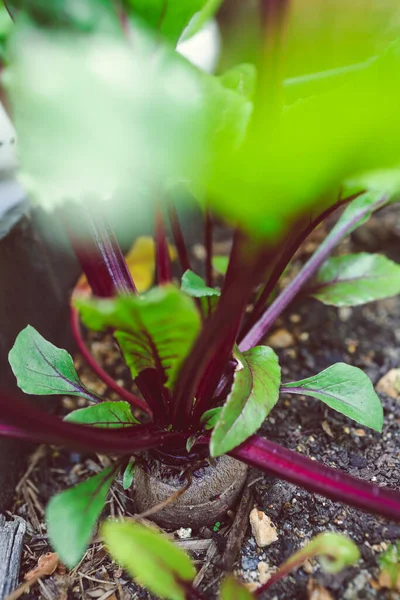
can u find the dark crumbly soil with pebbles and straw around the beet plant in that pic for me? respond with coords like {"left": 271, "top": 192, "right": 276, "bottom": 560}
{"left": 8, "top": 208, "right": 400, "bottom": 600}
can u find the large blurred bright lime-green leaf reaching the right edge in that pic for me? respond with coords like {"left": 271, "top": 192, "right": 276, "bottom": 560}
{"left": 208, "top": 38, "right": 400, "bottom": 238}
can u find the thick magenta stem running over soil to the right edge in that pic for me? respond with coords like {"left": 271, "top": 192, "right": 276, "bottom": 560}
{"left": 225, "top": 435, "right": 400, "bottom": 522}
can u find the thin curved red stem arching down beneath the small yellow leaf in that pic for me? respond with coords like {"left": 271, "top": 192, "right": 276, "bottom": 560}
{"left": 70, "top": 306, "right": 153, "bottom": 417}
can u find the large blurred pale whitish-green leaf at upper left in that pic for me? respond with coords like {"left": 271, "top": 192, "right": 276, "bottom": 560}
{"left": 4, "top": 20, "right": 205, "bottom": 211}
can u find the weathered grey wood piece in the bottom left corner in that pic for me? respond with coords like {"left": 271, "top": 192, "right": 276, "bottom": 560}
{"left": 0, "top": 515, "right": 26, "bottom": 600}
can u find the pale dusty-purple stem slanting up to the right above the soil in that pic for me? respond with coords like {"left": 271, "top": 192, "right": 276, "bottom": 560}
{"left": 239, "top": 197, "right": 387, "bottom": 352}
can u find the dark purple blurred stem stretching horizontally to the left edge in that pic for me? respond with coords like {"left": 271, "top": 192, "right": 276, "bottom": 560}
{"left": 0, "top": 394, "right": 182, "bottom": 455}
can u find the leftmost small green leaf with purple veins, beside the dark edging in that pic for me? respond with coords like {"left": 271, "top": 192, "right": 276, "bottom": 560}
{"left": 8, "top": 325, "right": 101, "bottom": 402}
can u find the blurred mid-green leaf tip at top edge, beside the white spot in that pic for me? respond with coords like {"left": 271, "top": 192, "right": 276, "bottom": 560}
{"left": 124, "top": 0, "right": 206, "bottom": 44}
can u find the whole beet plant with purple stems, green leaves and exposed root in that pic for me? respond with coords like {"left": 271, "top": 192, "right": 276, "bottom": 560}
{"left": 0, "top": 0, "right": 400, "bottom": 598}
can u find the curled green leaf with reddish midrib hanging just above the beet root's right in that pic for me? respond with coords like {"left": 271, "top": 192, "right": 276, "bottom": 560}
{"left": 210, "top": 346, "right": 280, "bottom": 456}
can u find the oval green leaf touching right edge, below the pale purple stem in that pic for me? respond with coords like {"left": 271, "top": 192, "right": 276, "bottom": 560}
{"left": 310, "top": 252, "right": 400, "bottom": 306}
